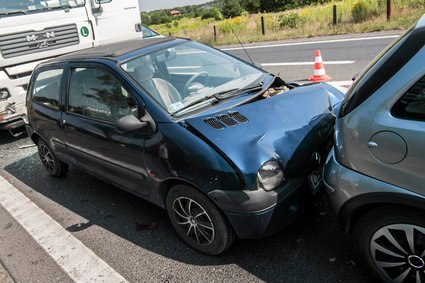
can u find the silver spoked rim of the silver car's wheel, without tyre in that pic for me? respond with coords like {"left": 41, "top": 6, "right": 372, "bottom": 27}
{"left": 370, "top": 224, "right": 425, "bottom": 283}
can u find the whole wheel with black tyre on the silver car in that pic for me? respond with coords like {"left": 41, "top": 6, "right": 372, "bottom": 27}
{"left": 353, "top": 207, "right": 425, "bottom": 282}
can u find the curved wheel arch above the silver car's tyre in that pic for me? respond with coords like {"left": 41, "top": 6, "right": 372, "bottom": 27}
{"left": 339, "top": 193, "right": 425, "bottom": 234}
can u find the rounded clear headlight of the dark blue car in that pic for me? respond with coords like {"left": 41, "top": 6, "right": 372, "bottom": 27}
{"left": 257, "top": 161, "right": 285, "bottom": 191}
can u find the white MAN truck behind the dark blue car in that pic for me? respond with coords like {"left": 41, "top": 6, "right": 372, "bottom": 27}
{"left": 0, "top": 0, "right": 142, "bottom": 134}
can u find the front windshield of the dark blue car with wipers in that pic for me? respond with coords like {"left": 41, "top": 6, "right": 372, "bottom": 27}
{"left": 121, "top": 42, "right": 265, "bottom": 115}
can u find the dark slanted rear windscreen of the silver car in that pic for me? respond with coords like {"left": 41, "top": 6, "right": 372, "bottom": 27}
{"left": 339, "top": 27, "right": 425, "bottom": 118}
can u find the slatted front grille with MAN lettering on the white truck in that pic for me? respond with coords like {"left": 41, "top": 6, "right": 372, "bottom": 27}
{"left": 0, "top": 24, "right": 80, "bottom": 58}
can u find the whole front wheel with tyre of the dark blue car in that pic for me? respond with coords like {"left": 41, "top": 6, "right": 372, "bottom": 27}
{"left": 166, "top": 185, "right": 234, "bottom": 255}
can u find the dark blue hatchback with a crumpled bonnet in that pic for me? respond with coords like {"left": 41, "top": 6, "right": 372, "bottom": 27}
{"left": 27, "top": 37, "right": 343, "bottom": 255}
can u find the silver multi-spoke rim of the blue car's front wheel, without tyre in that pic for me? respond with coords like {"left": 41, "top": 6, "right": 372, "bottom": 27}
{"left": 173, "top": 197, "right": 215, "bottom": 246}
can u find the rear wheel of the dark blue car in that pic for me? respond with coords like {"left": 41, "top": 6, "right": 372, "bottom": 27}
{"left": 37, "top": 139, "right": 69, "bottom": 177}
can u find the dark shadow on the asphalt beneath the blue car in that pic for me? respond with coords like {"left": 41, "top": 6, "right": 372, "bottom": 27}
{"left": 5, "top": 154, "right": 366, "bottom": 282}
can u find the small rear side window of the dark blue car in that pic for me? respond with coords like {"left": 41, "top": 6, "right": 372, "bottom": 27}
{"left": 31, "top": 69, "right": 63, "bottom": 110}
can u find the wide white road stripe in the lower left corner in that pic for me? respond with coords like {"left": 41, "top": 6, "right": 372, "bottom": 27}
{"left": 0, "top": 176, "right": 127, "bottom": 282}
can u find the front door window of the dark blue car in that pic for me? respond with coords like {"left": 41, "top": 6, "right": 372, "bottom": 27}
{"left": 68, "top": 68, "right": 138, "bottom": 122}
